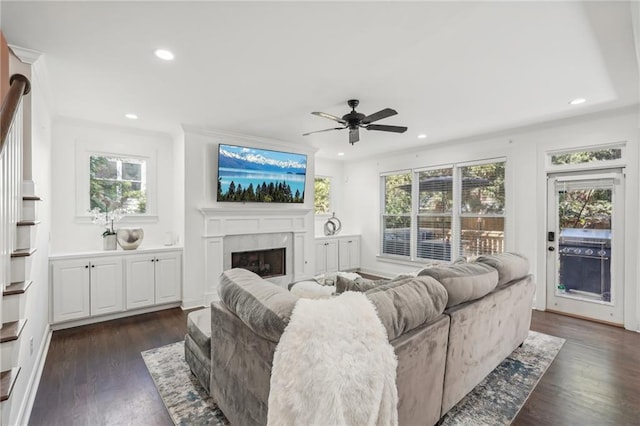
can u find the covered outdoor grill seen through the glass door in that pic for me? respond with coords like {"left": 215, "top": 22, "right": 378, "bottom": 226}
{"left": 558, "top": 228, "right": 611, "bottom": 302}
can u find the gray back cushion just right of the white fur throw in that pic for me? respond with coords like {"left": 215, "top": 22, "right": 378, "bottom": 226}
{"left": 365, "top": 277, "right": 447, "bottom": 340}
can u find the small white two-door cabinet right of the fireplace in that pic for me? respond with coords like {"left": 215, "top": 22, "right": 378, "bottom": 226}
{"left": 315, "top": 235, "right": 360, "bottom": 275}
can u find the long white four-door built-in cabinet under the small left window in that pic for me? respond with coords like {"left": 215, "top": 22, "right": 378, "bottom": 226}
{"left": 49, "top": 248, "right": 182, "bottom": 324}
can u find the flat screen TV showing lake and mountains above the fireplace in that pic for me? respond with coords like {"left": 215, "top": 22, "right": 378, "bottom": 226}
{"left": 217, "top": 144, "right": 307, "bottom": 203}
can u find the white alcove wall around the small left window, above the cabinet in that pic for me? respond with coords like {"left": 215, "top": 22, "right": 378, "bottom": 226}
{"left": 51, "top": 118, "right": 182, "bottom": 254}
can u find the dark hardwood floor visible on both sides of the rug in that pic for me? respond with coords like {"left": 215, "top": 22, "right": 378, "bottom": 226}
{"left": 30, "top": 308, "right": 640, "bottom": 426}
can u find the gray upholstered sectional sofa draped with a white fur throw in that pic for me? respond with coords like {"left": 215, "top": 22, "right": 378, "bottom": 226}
{"left": 185, "top": 253, "right": 534, "bottom": 425}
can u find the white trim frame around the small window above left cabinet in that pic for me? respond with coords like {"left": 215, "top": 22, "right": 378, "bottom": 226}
{"left": 75, "top": 142, "right": 158, "bottom": 224}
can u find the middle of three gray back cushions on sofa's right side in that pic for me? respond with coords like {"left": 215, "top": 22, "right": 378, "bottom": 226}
{"left": 419, "top": 263, "right": 498, "bottom": 307}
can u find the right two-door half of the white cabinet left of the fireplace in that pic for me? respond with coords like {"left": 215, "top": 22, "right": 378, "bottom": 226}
{"left": 125, "top": 253, "right": 182, "bottom": 309}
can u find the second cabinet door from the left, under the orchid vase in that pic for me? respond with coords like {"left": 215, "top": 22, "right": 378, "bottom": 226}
{"left": 90, "top": 257, "right": 124, "bottom": 315}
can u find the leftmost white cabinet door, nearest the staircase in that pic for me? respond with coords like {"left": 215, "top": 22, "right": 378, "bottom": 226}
{"left": 51, "top": 260, "right": 91, "bottom": 323}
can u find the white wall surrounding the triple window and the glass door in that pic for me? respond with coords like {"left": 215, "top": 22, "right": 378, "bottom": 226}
{"left": 342, "top": 107, "right": 640, "bottom": 329}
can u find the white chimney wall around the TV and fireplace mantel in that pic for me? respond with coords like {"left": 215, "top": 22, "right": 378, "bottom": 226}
{"left": 182, "top": 129, "right": 315, "bottom": 308}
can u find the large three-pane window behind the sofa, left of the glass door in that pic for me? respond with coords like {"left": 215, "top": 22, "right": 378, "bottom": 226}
{"left": 381, "top": 161, "right": 505, "bottom": 261}
